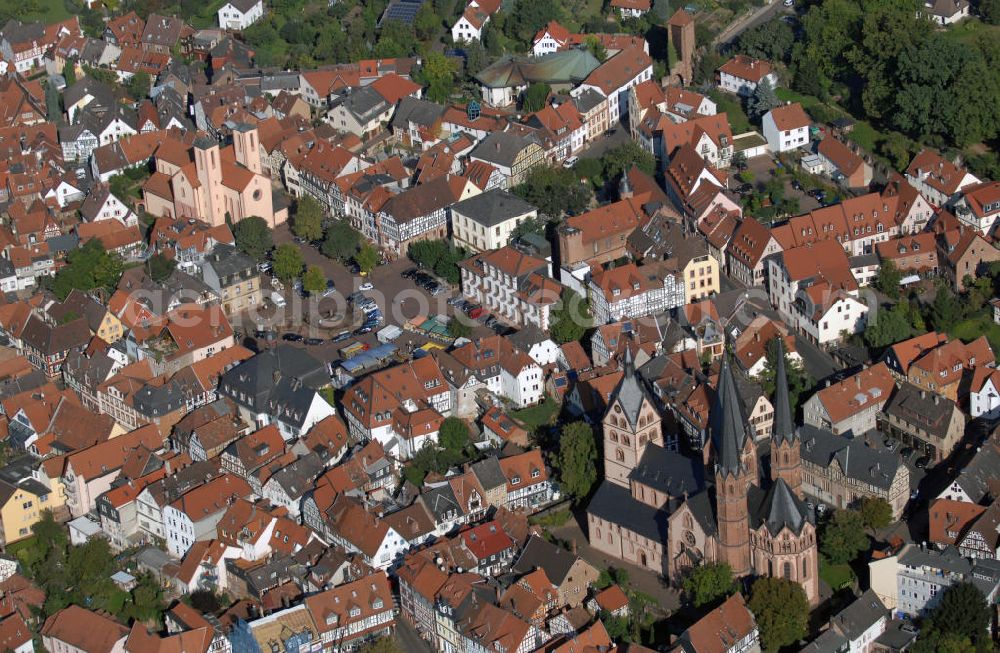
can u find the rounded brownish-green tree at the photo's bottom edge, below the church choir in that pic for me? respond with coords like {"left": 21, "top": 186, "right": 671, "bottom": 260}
{"left": 749, "top": 578, "right": 809, "bottom": 653}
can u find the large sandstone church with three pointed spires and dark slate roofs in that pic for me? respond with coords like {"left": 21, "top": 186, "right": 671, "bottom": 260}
{"left": 587, "top": 340, "right": 819, "bottom": 604}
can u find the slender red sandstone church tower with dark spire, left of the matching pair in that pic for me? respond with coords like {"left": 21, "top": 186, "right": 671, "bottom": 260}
{"left": 709, "top": 355, "right": 757, "bottom": 577}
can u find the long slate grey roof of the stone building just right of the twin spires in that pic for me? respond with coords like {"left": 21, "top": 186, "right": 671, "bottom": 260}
{"left": 799, "top": 424, "right": 900, "bottom": 490}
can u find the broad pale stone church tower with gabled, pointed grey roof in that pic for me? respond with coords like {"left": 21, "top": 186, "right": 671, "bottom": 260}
{"left": 603, "top": 347, "right": 663, "bottom": 489}
